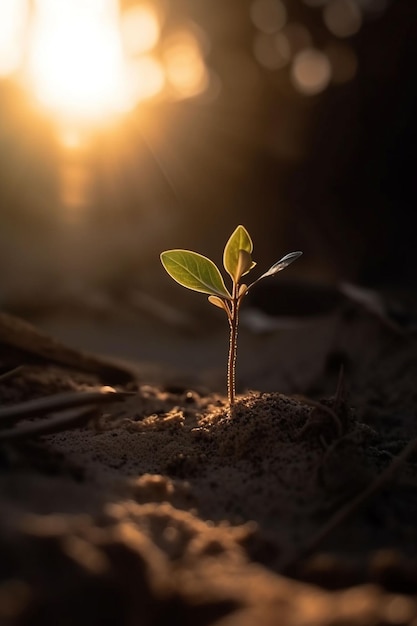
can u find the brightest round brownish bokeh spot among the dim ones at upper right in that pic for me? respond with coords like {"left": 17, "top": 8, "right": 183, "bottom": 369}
{"left": 291, "top": 48, "right": 332, "bottom": 96}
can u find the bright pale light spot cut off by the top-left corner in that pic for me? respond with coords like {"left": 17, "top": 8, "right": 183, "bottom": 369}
{"left": 0, "top": 0, "right": 28, "bottom": 78}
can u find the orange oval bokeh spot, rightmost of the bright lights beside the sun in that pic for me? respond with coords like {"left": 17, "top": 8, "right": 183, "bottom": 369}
{"left": 164, "top": 30, "right": 209, "bottom": 98}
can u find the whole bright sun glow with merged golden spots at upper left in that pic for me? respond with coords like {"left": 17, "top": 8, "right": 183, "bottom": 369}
{"left": 0, "top": 0, "right": 210, "bottom": 139}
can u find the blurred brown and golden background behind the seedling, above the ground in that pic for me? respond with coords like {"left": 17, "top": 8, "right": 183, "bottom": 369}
{"left": 0, "top": 0, "right": 417, "bottom": 378}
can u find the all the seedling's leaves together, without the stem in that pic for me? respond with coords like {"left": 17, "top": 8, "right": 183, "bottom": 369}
{"left": 161, "top": 226, "right": 302, "bottom": 306}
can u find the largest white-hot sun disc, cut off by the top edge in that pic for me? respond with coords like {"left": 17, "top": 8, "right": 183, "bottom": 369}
{"left": 27, "top": 0, "right": 126, "bottom": 120}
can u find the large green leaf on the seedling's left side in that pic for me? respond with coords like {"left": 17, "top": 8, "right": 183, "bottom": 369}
{"left": 161, "top": 250, "right": 232, "bottom": 300}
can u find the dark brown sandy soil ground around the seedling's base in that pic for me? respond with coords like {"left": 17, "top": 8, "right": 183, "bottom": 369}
{"left": 0, "top": 284, "right": 417, "bottom": 626}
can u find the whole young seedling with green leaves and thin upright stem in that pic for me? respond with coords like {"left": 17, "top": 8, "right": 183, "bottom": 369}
{"left": 161, "top": 226, "right": 302, "bottom": 409}
